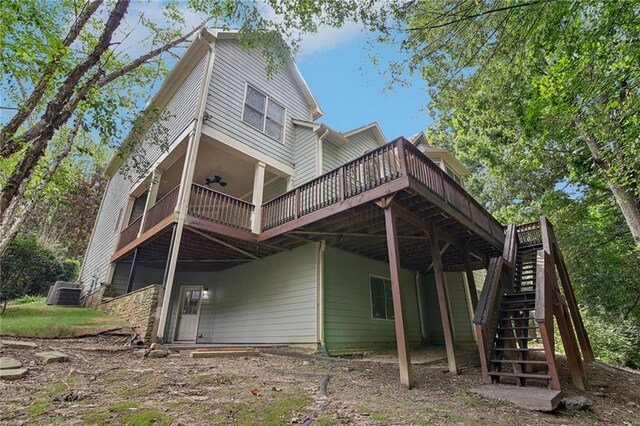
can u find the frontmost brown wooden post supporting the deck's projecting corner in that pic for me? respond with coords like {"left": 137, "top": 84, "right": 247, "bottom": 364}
{"left": 384, "top": 204, "right": 413, "bottom": 389}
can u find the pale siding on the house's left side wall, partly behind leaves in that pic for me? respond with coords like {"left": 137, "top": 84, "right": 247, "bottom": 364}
{"left": 80, "top": 56, "right": 206, "bottom": 293}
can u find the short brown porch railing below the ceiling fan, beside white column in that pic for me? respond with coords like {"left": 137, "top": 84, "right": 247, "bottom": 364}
{"left": 188, "top": 183, "right": 254, "bottom": 231}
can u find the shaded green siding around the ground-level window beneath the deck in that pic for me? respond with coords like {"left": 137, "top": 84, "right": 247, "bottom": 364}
{"left": 324, "top": 247, "right": 421, "bottom": 351}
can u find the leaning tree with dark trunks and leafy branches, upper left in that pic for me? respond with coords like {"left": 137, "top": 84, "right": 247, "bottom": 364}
{"left": 0, "top": 0, "right": 364, "bottom": 254}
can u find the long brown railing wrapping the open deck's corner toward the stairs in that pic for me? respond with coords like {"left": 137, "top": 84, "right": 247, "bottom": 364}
{"left": 262, "top": 138, "right": 504, "bottom": 242}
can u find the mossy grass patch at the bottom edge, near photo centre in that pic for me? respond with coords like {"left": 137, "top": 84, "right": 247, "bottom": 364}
{"left": 229, "top": 388, "right": 309, "bottom": 426}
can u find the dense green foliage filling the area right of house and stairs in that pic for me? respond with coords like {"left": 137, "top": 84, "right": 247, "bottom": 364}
{"left": 370, "top": 0, "right": 640, "bottom": 365}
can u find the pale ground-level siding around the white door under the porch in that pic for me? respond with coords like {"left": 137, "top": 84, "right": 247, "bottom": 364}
{"left": 169, "top": 244, "right": 317, "bottom": 344}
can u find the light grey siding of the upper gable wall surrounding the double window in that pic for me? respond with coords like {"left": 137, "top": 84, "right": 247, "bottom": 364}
{"left": 206, "top": 40, "right": 310, "bottom": 167}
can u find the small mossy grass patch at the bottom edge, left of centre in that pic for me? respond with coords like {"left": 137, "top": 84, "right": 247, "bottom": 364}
{"left": 84, "top": 401, "right": 173, "bottom": 426}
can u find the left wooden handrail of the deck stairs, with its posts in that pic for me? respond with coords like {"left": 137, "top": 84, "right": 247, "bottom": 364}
{"left": 473, "top": 225, "right": 518, "bottom": 383}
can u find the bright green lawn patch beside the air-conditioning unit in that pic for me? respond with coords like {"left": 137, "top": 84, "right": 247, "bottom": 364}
{"left": 2, "top": 302, "right": 128, "bottom": 339}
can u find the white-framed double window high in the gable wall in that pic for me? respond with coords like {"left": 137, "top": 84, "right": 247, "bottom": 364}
{"left": 242, "top": 84, "right": 286, "bottom": 142}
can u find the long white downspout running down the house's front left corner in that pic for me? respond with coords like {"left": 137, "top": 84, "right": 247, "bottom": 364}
{"left": 157, "top": 31, "right": 215, "bottom": 342}
